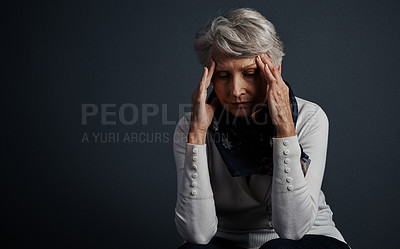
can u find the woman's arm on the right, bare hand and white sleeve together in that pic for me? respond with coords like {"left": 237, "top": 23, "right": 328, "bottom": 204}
{"left": 256, "top": 54, "right": 329, "bottom": 240}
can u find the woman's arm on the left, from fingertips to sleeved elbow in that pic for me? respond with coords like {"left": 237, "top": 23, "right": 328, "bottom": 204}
{"left": 174, "top": 61, "right": 218, "bottom": 244}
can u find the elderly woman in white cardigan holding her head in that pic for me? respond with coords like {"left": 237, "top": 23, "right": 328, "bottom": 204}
{"left": 174, "top": 9, "right": 349, "bottom": 249}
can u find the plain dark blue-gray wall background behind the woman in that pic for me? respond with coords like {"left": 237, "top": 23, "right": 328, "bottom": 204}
{"left": 0, "top": 0, "right": 400, "bottom": 249}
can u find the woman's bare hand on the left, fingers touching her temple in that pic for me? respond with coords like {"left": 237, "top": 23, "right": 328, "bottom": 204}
{"left": 188, "top": 60, "right": 219, "bottom": 145}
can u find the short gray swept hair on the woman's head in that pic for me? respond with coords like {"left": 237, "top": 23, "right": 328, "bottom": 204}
{"left": 194, "top": 8, "right": 285, "bottom": 67}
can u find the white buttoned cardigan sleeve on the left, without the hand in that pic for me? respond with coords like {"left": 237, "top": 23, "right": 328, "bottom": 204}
{"left": 173, "top": 115, "right": 218, "bottom": 244}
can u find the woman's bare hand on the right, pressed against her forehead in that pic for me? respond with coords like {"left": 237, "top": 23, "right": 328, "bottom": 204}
{"left": 256, "top": 54, "right": 296, "bottom": 138}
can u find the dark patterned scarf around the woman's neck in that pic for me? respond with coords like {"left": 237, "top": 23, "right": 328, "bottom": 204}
{"left": 207, "top": 81, "right": 311, "bottom": 176}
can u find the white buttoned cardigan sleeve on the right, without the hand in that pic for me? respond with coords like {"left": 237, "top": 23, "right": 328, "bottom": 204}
{"left": 271, "top": 105, "right": 329, "bottom": 240}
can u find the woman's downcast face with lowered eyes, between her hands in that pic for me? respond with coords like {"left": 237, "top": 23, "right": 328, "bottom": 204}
{"left": 211, "top": 54, "right": 272, "bottom": 117}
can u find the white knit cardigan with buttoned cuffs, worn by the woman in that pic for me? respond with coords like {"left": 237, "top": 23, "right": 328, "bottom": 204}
{"left": 173, "top": 97, "right": 345, "bottom": 248}
